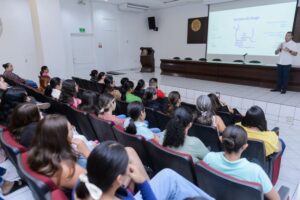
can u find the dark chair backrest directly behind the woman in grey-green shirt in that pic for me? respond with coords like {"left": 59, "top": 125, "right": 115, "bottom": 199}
{"left": 145, "top": 141, "right": 195, "bottom": 183}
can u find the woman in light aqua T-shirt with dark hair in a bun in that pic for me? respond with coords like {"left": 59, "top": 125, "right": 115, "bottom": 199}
{"left": 204, "top": 126, "right": 280, "bottom": 200}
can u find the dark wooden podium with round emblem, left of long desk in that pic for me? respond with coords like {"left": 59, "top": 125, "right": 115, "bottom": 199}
{"left": 141, "top": 47, "right": 155, "bottom": 72}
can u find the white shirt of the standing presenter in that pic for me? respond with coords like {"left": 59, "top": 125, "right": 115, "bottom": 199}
{"left": 278, "top": 40, "right": 298, "bottom": 65}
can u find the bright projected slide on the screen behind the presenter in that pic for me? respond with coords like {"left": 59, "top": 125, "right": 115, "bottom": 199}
{"left": 207, "top": 2, "right": 296, "bottom": 56}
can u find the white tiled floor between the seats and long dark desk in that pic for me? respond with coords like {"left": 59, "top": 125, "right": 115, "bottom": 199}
{"left": 0, "top": 69, "right": 300, "bottom": 200}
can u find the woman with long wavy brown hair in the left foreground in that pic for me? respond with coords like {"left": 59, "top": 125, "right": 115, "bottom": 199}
{"left": 27, "top": 115, "right": 90, "bottom": 189}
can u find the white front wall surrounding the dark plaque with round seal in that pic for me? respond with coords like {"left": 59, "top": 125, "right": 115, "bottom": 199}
{"left": 146, "top": 3, "right": 208, "bottom": 66}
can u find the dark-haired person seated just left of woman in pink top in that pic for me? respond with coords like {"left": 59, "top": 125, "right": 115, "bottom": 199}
{"left": 78, "top": 90, "right": 99, "bottom": 115}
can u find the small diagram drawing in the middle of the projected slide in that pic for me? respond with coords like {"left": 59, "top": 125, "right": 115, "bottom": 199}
{"left": 234, "top": 24, "right": 256, "bottom": 49}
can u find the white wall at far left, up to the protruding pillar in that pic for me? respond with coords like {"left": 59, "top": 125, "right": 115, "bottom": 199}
{"left": 0, "top": 0, "right": 39, "bottom": 80}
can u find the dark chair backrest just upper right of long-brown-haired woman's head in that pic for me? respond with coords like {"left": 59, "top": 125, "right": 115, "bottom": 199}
{"left": 64, "top": 105, "right": 97, "bottom": 140}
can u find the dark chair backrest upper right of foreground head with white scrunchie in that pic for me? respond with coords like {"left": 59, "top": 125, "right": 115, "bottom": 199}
{"left": 113, "top": 126, "right": 152, "bottom": 168}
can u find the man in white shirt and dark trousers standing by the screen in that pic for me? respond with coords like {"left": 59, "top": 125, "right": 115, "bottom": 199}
{"left": 271, "top": 32, "right": 298, "bottom": 94}
